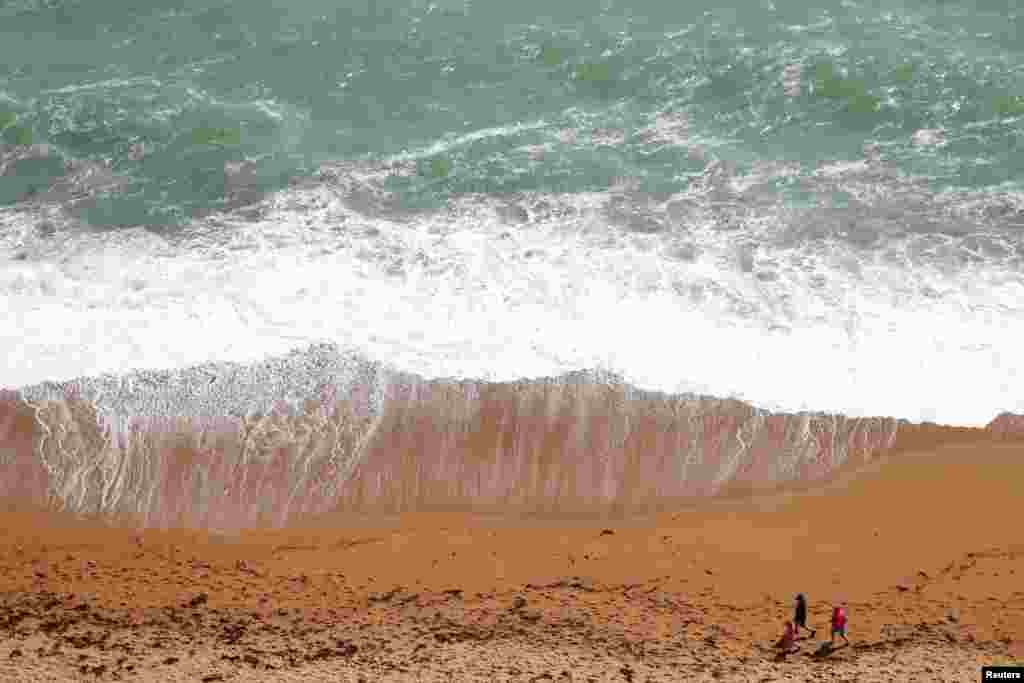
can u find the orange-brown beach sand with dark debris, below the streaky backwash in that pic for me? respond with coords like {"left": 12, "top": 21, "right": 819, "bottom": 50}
{"left": 0, "top": 432, "right": 1024, "bottom": 682}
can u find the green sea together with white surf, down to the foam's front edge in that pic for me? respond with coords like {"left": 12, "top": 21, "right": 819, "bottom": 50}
{"left": 0, "top": 0, "right": 1024, "bottom": 424}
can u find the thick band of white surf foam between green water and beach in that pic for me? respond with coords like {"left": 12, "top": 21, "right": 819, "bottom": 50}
{"left": 0, "top": 161, "right": 1024, "bottom": 425}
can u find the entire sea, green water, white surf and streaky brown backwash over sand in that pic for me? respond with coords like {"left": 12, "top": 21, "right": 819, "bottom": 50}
{"left": 0, "top": 0, "right": 1024, "bottom": 526}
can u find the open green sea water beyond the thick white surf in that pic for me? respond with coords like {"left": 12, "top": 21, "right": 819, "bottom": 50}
{"left": 0, "top": 0, "right": 1024, "bottom": 225}
